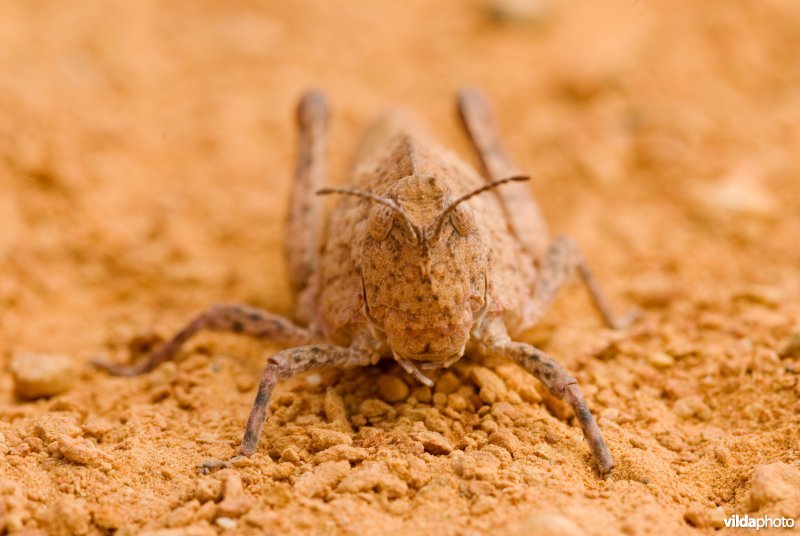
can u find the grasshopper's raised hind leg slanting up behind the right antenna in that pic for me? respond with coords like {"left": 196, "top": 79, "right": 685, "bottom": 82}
{"left": 458, "top": 89, "right": 549, "bottom": 259}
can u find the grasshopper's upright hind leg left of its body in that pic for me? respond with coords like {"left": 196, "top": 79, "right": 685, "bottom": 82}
{"left": 285, "top": 91, "right": 328, "bottom": 322}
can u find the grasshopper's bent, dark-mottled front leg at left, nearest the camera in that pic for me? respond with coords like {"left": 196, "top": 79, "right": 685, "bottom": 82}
{"left": 200, "top": 344, "right": 372, "bottom": 472}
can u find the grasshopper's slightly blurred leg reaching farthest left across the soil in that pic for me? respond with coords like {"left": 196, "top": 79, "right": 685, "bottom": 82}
{"left": 92, "top": 304, "right": 310, "bottom": 376}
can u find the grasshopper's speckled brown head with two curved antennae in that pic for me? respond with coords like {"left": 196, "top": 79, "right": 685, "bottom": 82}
{"left": 322, "top": 175, "right": 525, "bottom": 368}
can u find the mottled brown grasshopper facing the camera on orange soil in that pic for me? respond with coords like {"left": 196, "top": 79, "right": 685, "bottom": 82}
{"left": 96, "top": 89, "right": 634, "bottom": 477}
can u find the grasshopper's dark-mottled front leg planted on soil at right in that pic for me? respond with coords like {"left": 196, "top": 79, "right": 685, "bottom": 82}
{"left": 482, "top": 330, "right": 614, "bottom": 478}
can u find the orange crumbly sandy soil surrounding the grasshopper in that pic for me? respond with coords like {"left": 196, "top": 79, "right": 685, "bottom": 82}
{"left": 0, "top": 0, "right": 800, "bottom": 535}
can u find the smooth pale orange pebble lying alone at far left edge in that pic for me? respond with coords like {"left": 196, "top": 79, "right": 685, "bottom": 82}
{"left": 10, "top": 353, "right": 75, "bottom": 399}
